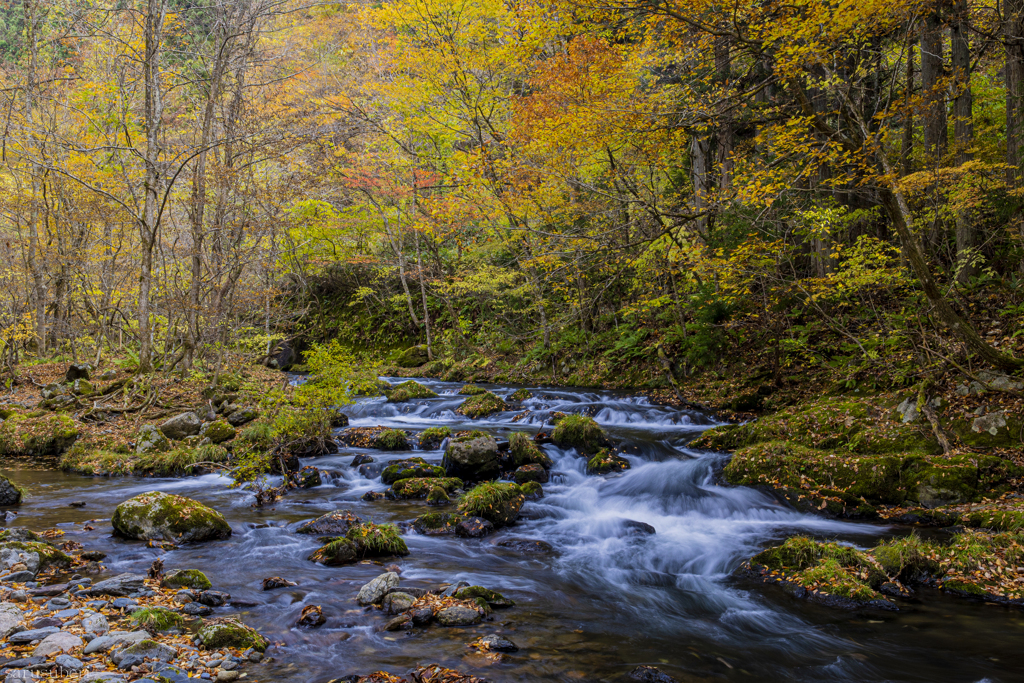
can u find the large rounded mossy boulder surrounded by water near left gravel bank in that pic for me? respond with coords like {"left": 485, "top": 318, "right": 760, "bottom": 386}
{"left": 111, "top": 490, "right": 231, "bottom": 543}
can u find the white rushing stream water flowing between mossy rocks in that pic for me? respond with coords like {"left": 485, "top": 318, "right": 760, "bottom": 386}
{"left": 7, "top": 380, "right": 1024, "bottom": 683}
